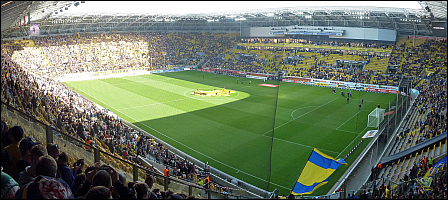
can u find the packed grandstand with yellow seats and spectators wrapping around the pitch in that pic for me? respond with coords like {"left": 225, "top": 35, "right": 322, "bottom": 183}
{"left": 1, "top": 2, "right": 447, "bottom": 199}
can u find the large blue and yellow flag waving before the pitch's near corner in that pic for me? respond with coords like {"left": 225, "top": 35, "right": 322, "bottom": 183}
{"left": 291, "top": 148, "right": 347, "bottom": 195}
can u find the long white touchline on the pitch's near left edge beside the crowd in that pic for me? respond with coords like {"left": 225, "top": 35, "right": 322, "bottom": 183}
{"left": 65, "top": 84, "right": 291, "bottom": 190}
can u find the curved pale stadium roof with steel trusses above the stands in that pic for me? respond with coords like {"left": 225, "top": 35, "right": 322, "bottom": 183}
{"left": 1, "top": 1, "right": 446, "bottom": 38}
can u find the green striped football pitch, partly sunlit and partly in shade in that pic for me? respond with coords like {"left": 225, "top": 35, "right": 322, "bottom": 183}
{"left": 65, "top": 71, "right": 396, "bottom": 195}
